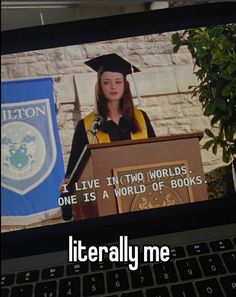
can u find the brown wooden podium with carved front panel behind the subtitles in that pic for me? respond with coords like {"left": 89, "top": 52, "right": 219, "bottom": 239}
{"left": 68, "top": 133, "right": 208, "bottom": 220}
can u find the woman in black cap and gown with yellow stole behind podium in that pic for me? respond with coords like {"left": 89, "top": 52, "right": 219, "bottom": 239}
{"left": 66, "top": 54, "right": 155, "bottom": 182}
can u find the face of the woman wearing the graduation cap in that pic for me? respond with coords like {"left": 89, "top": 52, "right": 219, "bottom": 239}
{"left": 101, "top": 71, "right": 124, "bottom": 101}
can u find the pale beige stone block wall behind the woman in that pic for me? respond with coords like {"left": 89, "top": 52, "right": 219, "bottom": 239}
{"left": 1, "top": 33, "right": 222, "bottom": 172}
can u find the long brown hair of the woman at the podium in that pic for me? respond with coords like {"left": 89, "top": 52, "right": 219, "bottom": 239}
{"left": 95, "top": 73, "right": 140, "bottom": 133}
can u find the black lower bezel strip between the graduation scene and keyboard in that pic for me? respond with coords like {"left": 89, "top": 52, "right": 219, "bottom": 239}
{"left": 1, "top": 197, "right": 236, "bottom": 259}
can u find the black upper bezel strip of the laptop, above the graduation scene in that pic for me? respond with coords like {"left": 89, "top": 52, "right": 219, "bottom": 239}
{"left": 2, "top": 2, "right": 236, "bottom": 55}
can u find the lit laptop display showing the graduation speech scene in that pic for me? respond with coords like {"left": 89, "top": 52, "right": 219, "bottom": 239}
{"left": 1, "top": 2, "right": 235, "bottom": 238}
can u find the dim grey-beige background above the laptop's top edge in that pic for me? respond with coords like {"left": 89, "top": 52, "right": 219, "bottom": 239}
{"left": 1, "top": 0, "right": 171, "bottom": 31}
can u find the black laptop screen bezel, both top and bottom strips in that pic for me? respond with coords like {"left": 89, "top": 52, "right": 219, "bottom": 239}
{"left": 2, "top": 2, "right": 236, "bottom": 258}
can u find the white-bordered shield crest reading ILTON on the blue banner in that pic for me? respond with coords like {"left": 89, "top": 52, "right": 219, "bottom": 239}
{"left": 1, "top": 99, "right": 56, "bottom": 195}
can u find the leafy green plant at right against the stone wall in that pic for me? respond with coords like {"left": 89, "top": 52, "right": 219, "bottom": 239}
{"left": 172, "top": 24, "right": 236, "bottom": 163}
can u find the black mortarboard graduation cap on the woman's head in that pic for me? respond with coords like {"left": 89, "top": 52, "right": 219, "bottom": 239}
{"left": 85, "top": 54, "right": 140, "bottom": 75}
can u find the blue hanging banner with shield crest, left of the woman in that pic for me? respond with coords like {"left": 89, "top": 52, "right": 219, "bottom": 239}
{"left": 1, "top": 78, "right": 64, "bottom": 225}
